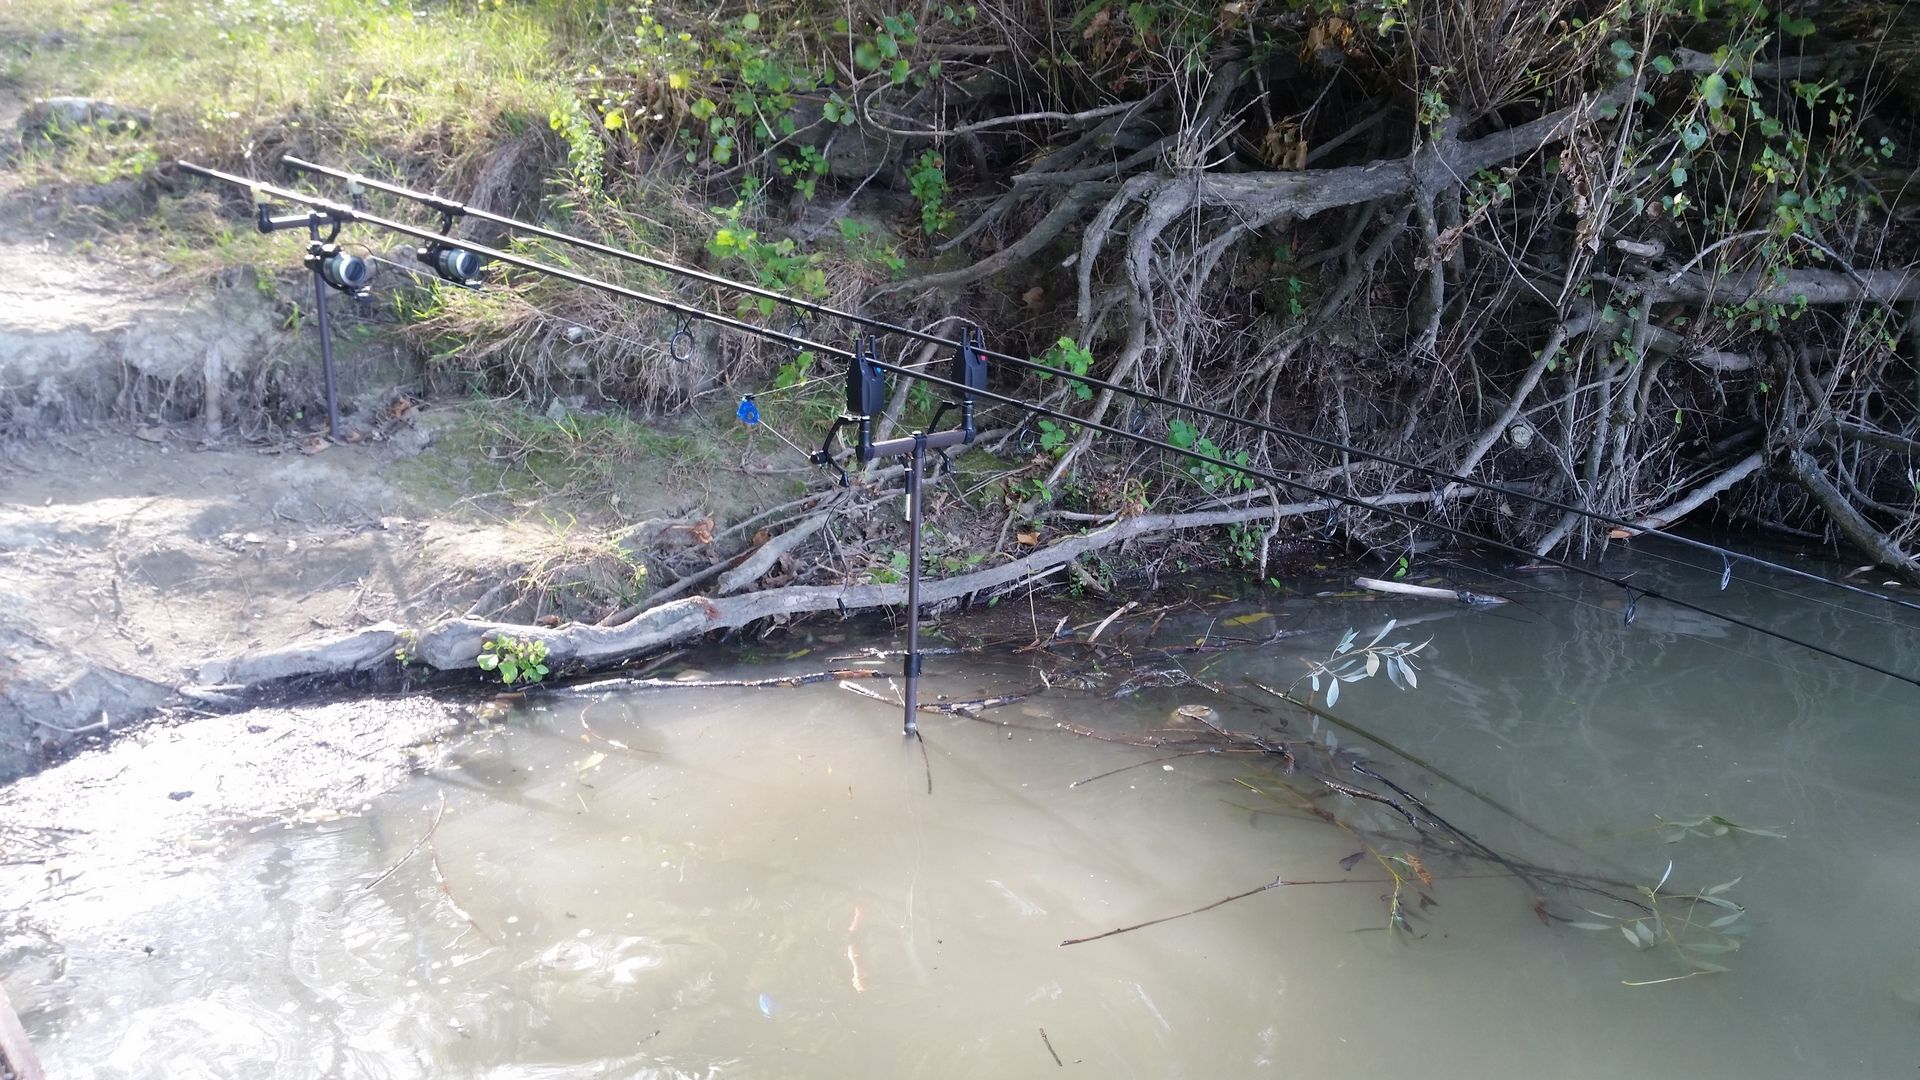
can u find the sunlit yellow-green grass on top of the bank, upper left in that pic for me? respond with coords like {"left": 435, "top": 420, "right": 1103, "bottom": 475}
{"left": 0, "top": 0, "right": 586, "bottom": 181}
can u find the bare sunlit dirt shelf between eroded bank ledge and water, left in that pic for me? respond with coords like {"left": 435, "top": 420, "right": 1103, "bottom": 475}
{"left": 0, "top": 429, "right": 538, "bottom": 776}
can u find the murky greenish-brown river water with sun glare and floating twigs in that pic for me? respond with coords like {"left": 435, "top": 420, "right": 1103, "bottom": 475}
{"left": 6, "top": 559, "right": 1920, "bottom": 1078}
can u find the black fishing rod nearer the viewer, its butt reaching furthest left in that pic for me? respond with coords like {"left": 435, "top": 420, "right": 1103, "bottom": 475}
{"left": 179, "top": 161, "right": 1920, "bottom": 686}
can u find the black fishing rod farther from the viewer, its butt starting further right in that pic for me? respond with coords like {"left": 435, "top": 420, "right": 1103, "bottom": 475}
{"left": 280, "top": 156, "right": 1920, "bottom": 611}
